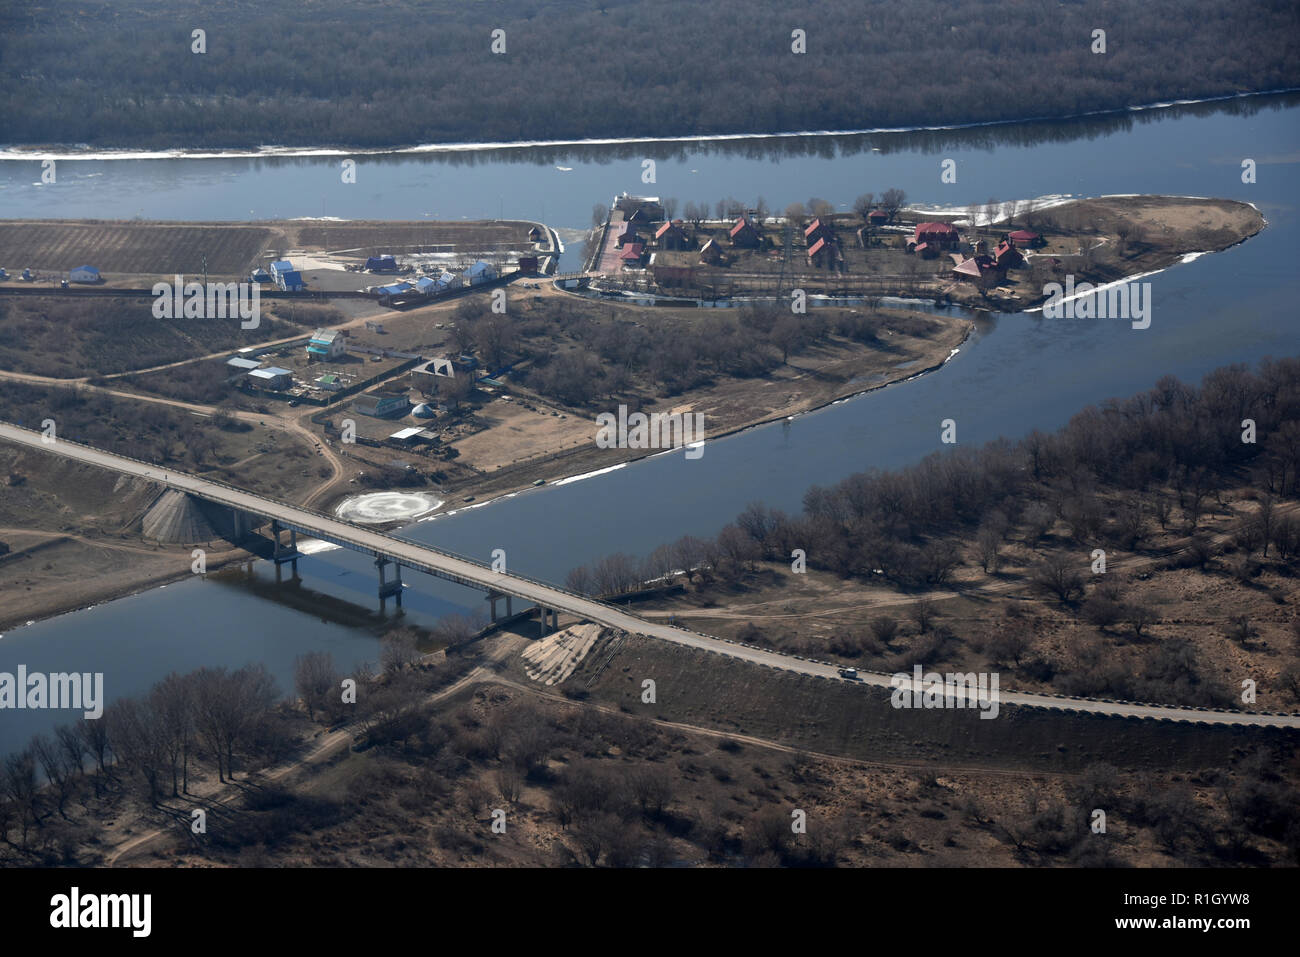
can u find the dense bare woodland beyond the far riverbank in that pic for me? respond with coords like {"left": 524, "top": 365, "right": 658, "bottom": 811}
{"left": 0, "top": 0, "right": 1300, "bottom": 147}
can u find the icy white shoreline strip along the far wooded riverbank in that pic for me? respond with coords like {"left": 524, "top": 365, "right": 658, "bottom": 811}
{"left": 0, "top": 87, "right": 1300, "bottom": 163}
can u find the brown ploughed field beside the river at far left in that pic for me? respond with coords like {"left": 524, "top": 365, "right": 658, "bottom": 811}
{"left": 0, "top": 220, "right": 276, "bottom": 276}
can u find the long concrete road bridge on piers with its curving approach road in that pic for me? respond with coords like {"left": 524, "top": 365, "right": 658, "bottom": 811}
{"left": 0, "top": 423, "right": 1300, "bottom": 728}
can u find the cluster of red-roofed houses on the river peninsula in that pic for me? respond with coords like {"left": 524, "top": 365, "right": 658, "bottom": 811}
{"left": 589, "top": 191, "right": 1055, "bottom": 302}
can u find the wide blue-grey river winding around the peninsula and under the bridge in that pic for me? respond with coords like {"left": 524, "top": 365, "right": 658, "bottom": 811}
{"left": 0, "top": 95, "right": 1300, "bottom": 753}
